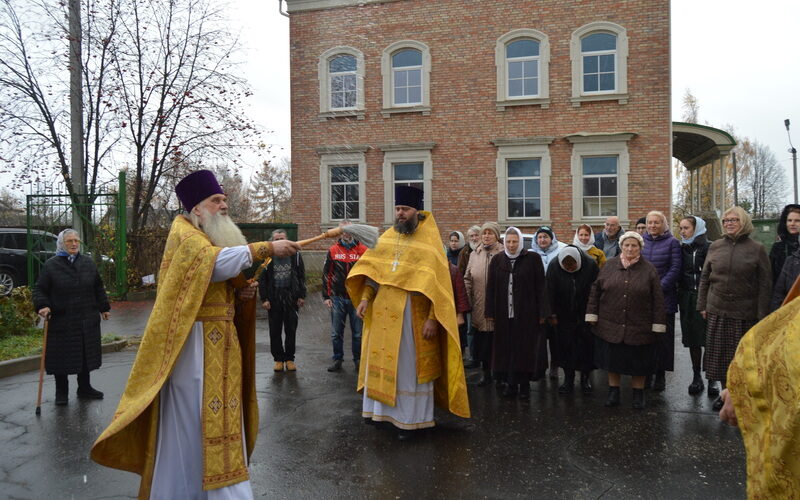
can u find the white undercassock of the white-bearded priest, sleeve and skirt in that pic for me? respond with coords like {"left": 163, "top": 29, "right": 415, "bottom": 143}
{"left": 150, "top": 245, "right": 253, "bottom": 500}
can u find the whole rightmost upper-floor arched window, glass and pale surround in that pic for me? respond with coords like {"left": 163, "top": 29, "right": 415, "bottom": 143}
{"left": 570, "top": 21, "right": 629, "bottom": 106}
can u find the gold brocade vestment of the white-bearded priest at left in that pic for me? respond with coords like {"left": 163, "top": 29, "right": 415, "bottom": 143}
{"left": 91, "top": 216, "right": 260, "bottom": 498}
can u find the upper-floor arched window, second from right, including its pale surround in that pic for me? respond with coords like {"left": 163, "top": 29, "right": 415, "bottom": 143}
{"left": 495, "top": 29, "right": 550, "bottom": 110}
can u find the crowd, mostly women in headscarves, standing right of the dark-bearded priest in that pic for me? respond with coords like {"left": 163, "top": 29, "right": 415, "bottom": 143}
{"left": 446, "top": 205, "right": 800, "bottom": 410}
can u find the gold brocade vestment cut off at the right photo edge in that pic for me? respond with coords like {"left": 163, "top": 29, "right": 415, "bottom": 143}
{"left": 728, "top": 299, "right": 800, "bottom": 499}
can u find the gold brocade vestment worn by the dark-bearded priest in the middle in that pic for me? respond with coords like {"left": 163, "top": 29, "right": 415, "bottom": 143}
{"left": 346, "top": 211, "right": 470, "bottom": 418}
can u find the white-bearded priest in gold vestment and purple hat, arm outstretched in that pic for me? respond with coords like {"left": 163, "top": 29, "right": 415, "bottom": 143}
{"left": 92, "top": 170, "right": 298, "bottom": 499}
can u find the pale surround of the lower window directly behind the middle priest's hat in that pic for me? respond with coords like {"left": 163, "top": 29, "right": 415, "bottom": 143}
{"left": 380, "top": 143, "right": 435, "bottom": 224}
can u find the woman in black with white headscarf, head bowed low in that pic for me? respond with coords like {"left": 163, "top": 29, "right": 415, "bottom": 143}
{"left": 547, "top": 244, "right": 605, "bottom": 394}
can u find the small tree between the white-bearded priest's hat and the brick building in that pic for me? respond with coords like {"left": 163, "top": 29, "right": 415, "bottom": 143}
{"left": 250, "top": 157, "right": 292, "bottom": 222}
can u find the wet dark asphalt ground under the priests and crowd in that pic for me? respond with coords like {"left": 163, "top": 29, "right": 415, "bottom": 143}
{"left": 0, "top": 295, "right": 746, "bottom": 499}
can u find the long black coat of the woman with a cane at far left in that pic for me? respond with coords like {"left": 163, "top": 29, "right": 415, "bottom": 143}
{"left": 33, "top": 254, "right": 111, "bottom": 375}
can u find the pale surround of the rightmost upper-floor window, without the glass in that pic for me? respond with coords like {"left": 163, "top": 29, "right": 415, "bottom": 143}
{"left": 569, "top": 21, "right": 630, "bottom": 107}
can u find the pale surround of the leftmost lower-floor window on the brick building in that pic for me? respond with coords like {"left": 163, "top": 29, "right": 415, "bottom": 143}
{"left": 317, "top": 145, "right": 368, "bottom": 228}
